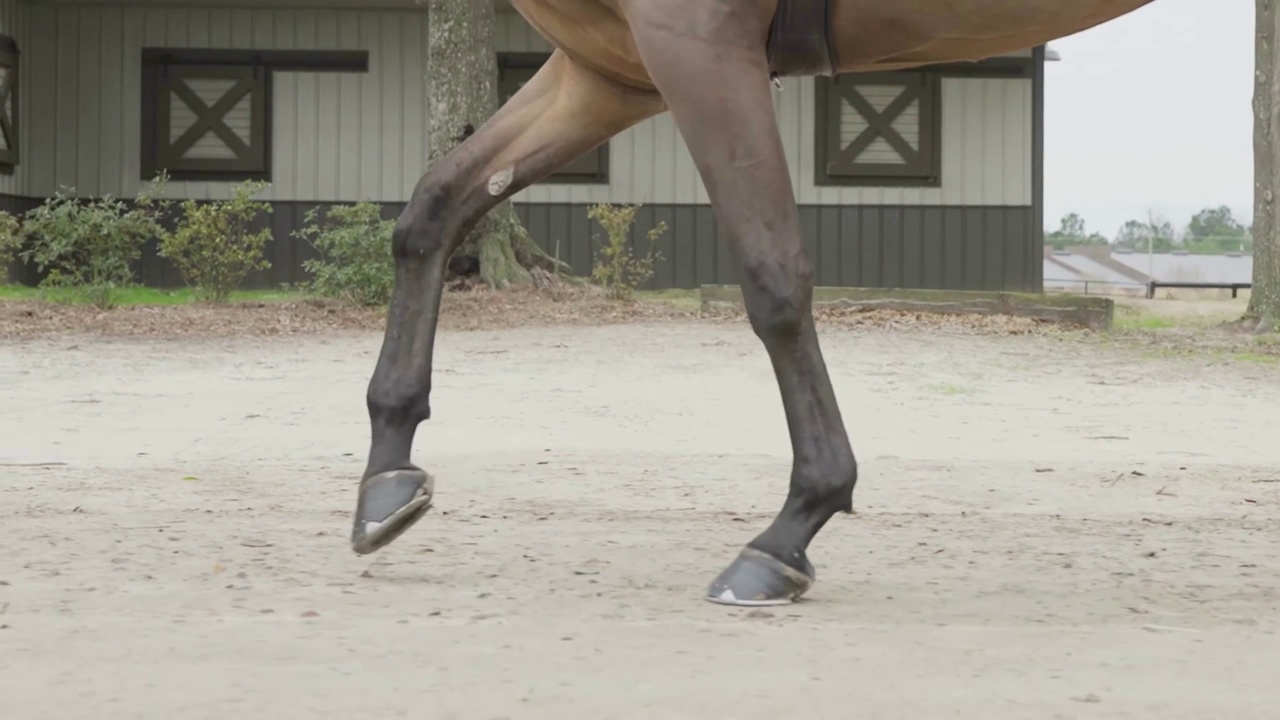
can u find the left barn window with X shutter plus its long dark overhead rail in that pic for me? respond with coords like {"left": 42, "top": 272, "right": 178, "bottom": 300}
{"left": 142, "top": 49, "right": 369, "bottom": 182}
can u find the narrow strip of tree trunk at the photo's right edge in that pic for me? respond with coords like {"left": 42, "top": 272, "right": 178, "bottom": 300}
{"left": 1244, "top": 0, "right": 1280, "bottom": 332}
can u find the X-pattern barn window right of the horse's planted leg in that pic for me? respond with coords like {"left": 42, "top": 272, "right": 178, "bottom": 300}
{"left": 814, "top": 72, "right": 942, "bottom": 187}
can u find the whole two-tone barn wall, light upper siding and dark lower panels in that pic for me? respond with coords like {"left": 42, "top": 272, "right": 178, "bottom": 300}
{"left": 0, "top": 0, "right": 1042, "bottom": 290}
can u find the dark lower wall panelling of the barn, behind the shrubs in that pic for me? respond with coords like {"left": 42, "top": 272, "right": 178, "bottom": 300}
{"left": 0, "top": 197, "right": 1042, "bottom": 291}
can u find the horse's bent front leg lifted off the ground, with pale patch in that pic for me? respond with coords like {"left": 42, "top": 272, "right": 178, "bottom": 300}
{"left": 351, "top": 51, "right": 664, "bottom": 553}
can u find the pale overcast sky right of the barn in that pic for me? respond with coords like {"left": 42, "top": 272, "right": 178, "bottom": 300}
{"left": 1044, "top": 0, "right": 1254, "bottom": 237}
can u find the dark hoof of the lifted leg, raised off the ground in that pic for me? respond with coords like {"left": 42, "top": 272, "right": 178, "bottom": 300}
{"left": 351, "top": 468, "right": 435, "bottom": 555}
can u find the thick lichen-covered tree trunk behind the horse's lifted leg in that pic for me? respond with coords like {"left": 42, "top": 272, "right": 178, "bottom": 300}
{"left": 426, "top": 0, "right": 563, "bottom": 288}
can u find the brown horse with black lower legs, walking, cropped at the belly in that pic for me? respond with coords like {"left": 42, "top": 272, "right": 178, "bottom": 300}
{"left": 351, "top": 0, "right": 1152, "bottom": 606}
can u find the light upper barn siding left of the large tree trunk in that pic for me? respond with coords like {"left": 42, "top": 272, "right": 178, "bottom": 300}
{"left": 23, "top": 0, "right": 428, "bottom": 201}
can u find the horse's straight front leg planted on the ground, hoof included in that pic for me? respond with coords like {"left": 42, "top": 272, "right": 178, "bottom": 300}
{"left": 625, "top": 0, "right": 858, "bottom": 605}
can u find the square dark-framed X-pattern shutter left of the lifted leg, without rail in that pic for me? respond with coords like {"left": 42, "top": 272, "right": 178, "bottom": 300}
{"left": 156, "top": 65, "right": 268, "bottom": 174}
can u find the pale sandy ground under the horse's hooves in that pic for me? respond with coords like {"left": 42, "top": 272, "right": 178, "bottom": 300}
{"left": 0, "top": 323, "right": 1280, "bottom": 720}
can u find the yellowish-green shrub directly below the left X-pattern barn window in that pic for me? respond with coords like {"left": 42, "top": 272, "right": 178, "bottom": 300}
{"left": 160, "top": 182, "right": 271, "bottom": 302}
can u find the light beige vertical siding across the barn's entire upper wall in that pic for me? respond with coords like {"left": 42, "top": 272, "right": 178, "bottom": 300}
{"left": 22, "top": 0, "right": 1032, "bottom": 206}
